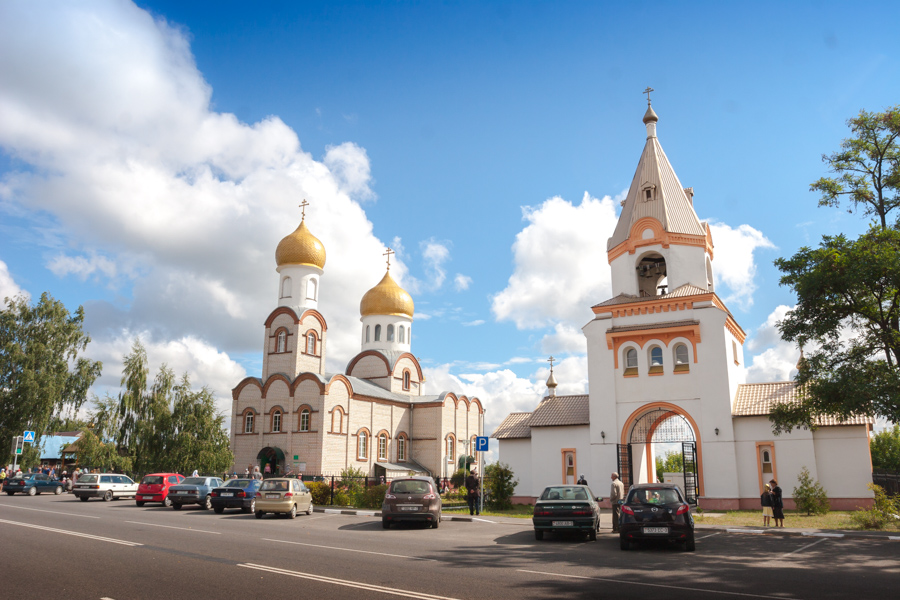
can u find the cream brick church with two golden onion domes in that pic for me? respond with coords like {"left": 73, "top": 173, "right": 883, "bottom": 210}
{"left": 231, "top": 214, "right": 484, "bottom": 477}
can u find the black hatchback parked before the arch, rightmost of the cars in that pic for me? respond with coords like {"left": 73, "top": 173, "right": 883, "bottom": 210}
{"left": 619, "top": 483, "right": 694, "bottom": 552}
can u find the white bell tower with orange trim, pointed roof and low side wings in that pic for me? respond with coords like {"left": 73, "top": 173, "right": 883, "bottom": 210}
{"left": 492, "top": 100, "right": 873, "bottom": 509}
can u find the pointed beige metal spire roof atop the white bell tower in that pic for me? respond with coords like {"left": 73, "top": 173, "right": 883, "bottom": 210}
{"left": 606, "top": 101, "right": 706, "bottom": 251}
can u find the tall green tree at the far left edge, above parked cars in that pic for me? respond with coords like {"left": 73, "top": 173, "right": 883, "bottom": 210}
{"left": 0, "top": 293, "right": 102, "bottom": 466}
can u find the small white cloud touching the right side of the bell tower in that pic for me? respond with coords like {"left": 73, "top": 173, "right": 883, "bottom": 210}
{"left": 710, "top": 223, "right": 775, "bottom": 310}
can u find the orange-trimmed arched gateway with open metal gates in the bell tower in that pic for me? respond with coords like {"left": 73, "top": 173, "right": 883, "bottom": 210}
{"left": 617, "top": 402, "right": 703, "bottom": 505}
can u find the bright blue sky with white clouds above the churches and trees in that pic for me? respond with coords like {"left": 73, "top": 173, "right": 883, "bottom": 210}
{"left": 0, "top": 1, "right": 900, "bottom": 436}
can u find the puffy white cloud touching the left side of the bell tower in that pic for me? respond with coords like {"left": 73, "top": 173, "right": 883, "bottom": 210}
{"left": 491, "top": 192, "right": 616, "bottom": 329}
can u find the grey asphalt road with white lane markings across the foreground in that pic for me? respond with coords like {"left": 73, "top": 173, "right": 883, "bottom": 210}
{"left": 0, "top": 494, "right": 900, "bottom": 600}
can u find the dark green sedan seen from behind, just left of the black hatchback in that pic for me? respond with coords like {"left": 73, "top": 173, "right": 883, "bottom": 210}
{"left": 531, "top": 485, "right": 600, "bottom": 540}
